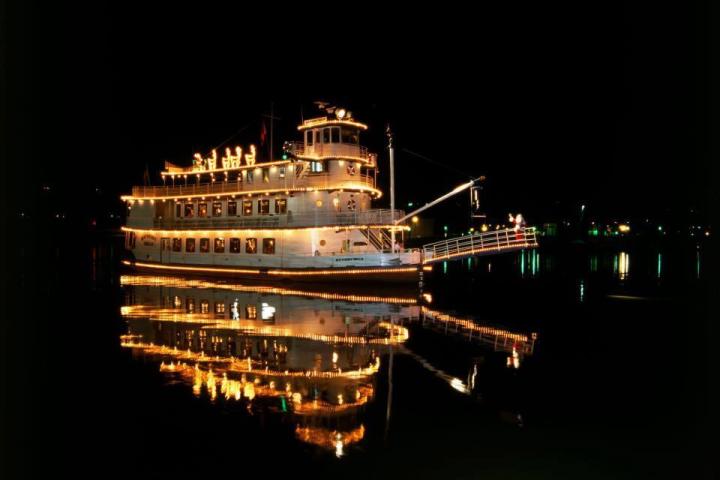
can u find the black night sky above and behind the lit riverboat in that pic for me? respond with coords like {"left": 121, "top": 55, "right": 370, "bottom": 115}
{"left": 4, "top": 4, "right": 709, "bottom": 227}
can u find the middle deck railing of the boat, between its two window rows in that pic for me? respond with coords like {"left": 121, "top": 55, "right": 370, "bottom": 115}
{"left": 153, "top": 209, "right": 405, "bottom": 230}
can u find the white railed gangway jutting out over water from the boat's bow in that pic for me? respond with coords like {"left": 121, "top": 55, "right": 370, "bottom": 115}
{"left": 423, "top": 227, "right": 537, "bottom": 263}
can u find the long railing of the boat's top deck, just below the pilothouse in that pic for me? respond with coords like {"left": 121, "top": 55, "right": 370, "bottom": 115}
{"left": 132, "top": 173, "right": 375, "bottom": 199}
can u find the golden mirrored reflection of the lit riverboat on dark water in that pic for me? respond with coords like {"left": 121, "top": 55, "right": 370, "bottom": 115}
{"left": 121, "top": 275, "right": 534, "bottom": 455}
